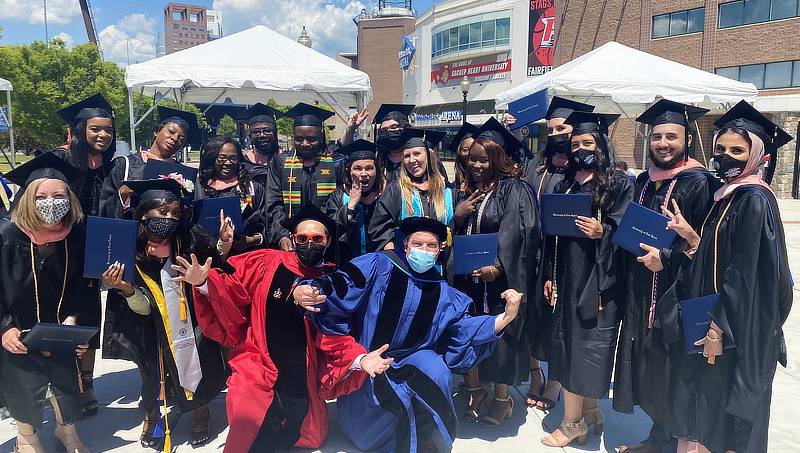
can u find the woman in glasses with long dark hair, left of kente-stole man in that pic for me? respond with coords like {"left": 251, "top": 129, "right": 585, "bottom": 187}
{"left": 200, "top": 137, "right": 268, "bottom": 255}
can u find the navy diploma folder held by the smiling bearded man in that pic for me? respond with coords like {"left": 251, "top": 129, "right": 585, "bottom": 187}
{"left": 611, "top": 202, "right": 675, "bottom": 256}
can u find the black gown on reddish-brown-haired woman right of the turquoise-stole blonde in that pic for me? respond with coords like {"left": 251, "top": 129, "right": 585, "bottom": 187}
{"left": 448, "top": 178, "right": 540, "bottom": 385}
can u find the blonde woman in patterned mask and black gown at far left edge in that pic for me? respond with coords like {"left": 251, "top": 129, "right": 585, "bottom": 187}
{"left": 0, "top": 153, "right": 94, "bottom": 453}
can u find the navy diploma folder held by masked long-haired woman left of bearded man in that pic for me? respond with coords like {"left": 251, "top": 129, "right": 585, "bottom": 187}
{"left": 541, "top": 193, "right": 592, "bottom": 238}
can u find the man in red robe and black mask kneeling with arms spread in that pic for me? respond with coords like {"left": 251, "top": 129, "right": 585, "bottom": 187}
{"left": 176, "top": 205, "right": 392, "bottom": 453}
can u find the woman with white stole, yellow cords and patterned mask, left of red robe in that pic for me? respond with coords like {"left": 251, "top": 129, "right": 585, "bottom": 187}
{"left": 103, "top": 179, "right": 230, "bottom": 450}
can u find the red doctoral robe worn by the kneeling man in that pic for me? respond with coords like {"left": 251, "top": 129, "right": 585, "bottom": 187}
{"left": 194, "top": 250, "right": 366, "bottom": 453}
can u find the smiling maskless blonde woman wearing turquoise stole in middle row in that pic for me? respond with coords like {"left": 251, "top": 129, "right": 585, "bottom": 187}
{"left": 369, "top": 128, "right": 454, "bottom": 250}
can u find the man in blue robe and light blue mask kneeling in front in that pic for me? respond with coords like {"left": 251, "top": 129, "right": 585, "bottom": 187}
{"left": 294, "top": 217, "right": 522, "bottom": 453}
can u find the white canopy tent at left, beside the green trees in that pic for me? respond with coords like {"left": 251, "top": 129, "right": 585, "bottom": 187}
{"left": 125, "top": 25, "right": 372, "bottom": 150}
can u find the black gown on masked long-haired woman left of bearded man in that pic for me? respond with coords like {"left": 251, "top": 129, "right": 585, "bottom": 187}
{"left": 534, "top": 175, "right": 634, "bottom": 398}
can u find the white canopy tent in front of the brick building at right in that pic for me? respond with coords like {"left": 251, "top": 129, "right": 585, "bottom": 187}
{"left": 496, "top": 41, "right": 758, "bottom": 166}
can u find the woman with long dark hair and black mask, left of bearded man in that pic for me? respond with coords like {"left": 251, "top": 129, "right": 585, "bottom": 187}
{"left": 535, "top": 112, "right": 634, "bottom": 447}
